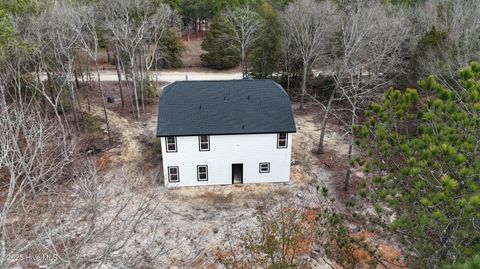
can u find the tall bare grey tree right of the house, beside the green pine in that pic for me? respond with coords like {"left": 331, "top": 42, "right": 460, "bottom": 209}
{"left": 330, "top": 0, "right": 412, "bottom": 190}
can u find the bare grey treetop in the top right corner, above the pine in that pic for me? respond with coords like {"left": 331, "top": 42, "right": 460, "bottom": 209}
{"left": 410, "top": 0, "right": 480, "bottom": 83}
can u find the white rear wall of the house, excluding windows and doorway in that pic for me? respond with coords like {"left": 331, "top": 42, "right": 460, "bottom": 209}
{"left": 161, "top": 133, "right": 293, "bottom": 187}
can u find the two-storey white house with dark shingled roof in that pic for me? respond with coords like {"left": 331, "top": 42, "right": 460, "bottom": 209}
{"left": 157, "top": 79, "right": 296, "bottom": 187}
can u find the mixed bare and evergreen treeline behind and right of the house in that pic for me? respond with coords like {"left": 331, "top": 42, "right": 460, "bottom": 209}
{"left": 202, "top": 0, "right": 480, "bottom": 189}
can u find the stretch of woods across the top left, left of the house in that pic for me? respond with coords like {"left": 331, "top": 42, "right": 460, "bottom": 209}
{"left": 0, "top": 0, "right": 183, "bottom": 138}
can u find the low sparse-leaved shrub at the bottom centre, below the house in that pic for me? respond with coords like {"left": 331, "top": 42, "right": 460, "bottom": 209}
{"left": 217, "top": 203, "right": 316, "bottom": 268}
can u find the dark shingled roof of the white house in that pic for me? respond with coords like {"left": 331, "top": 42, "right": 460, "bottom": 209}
{"left": 157, "top": 79, "right": 296, "bottom": 136}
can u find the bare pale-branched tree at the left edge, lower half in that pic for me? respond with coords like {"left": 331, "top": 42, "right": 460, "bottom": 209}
{"left": 0, "top": 104, "right": 74, "bottom": 267}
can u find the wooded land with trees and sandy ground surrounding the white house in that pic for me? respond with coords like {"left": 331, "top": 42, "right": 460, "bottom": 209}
{"left": 0, "top": 0, "right": 480, "bottom": 269}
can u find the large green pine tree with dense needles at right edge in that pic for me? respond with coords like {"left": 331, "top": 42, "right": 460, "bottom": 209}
{"left": 355, "top": 63, "right": 480, "bottom": 268}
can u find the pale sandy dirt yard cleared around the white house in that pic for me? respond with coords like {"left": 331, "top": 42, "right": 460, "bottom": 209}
{"left": 75, "top": 87, "right": 347, "bottom": 268}
